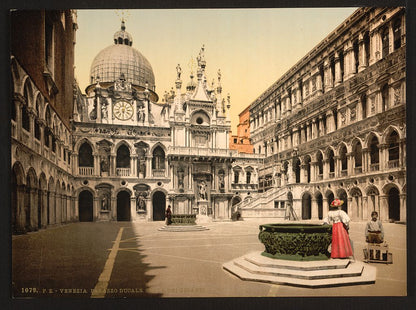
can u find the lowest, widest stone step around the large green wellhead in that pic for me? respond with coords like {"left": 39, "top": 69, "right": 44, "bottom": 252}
{"left": 223, "top": 261, "right": 376, "bottom": 288}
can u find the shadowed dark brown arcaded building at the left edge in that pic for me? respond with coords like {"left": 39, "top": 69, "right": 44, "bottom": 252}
{"left": 10, "top": 10, "right": 78, "bottom": 233}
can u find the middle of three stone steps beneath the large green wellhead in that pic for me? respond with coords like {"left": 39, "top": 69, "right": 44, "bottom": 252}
{"left": 234, "top": 258, "right": 364, "bottom": 280}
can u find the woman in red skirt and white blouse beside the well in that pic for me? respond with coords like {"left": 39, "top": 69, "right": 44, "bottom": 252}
{"left": 324, "top": 199, "right": 353, "bottom": 258}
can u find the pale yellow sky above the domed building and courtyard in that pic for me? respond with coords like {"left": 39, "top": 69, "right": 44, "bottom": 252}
{"left": 75, "top": 7, "right": 357, "bottom": 134}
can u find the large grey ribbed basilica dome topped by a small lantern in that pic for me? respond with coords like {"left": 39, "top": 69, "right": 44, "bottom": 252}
{"left": 90, "top": 21, "right": 155, "bottom": 91}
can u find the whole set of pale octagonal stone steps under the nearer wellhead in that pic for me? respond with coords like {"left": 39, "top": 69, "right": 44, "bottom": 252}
{"left": 223, "top": 251, "right": 376, "bottom": 288}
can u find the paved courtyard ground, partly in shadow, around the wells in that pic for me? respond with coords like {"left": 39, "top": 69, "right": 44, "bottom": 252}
{"left": 12, "top": 219, "right": 407, "bottom": 298}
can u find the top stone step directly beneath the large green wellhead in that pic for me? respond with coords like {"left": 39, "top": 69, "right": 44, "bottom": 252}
{"left": 244, "top": 251, "right": 350, "bottom": 271}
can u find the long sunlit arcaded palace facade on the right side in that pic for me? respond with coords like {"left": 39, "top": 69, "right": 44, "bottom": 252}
{"left": 238, "top": 8, "right": 406, "bottom": 222}
